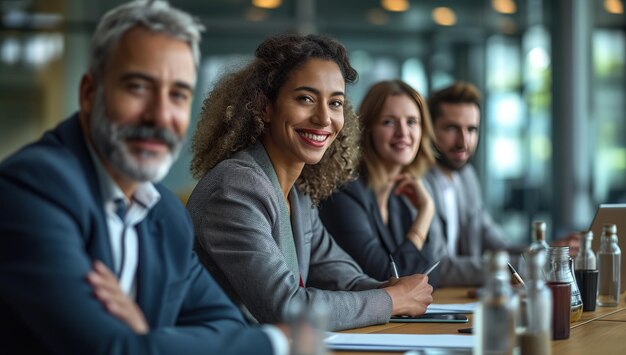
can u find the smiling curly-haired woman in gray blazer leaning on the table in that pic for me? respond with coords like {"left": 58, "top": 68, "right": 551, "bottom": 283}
{"left": 187, "top": 35, "right": 432, "bottom": 330}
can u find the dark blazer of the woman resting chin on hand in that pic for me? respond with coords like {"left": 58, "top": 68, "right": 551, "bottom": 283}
{"left": 320, "top": 176, "right": 433, "bottom": 283}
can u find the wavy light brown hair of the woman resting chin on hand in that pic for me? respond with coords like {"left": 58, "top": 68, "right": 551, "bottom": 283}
{"left": 359, "top": 80, "right": 435, "bottom": 188}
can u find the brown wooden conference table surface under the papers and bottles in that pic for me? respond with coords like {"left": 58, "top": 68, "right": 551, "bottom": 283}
{"left": 330, "top": 288, "right": 626, "bottom": 355}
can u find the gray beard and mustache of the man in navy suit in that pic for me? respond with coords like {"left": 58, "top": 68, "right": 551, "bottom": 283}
{"left": 90, "top": 87, "right": 183, "bottom": 182}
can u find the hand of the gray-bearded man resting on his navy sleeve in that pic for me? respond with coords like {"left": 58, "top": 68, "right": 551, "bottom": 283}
{"left": 87, "top": 260, "right": 149, "bottom": 335}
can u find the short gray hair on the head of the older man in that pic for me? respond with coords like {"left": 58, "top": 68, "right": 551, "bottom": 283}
{"left": 89, "top": 0, "right": 204, "bottom": 77}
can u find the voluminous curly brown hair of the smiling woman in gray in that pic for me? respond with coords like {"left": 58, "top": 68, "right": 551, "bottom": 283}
{"left": 191, "top": 34, "right": 360, "bottom": 205}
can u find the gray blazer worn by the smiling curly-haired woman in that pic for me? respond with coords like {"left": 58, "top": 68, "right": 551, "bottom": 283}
{"left": 187, "top": 144, "right": 392, "bottom": 330}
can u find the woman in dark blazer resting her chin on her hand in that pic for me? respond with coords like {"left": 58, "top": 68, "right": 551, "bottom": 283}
{"left": 320, "top": 80, "right": 437, "bottom": 280}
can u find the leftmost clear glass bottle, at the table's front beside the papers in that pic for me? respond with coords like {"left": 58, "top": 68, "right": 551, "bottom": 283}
{"left": 474, "top": 251, "right": 519, "bottom": 355}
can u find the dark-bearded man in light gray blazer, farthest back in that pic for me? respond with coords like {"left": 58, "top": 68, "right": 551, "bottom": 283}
{"left": 424, "top": 82, "right": 506, "bottom": 286}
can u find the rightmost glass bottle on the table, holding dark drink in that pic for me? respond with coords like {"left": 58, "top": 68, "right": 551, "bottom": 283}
{"left": 598, "top": 224, "right": 622, "bottom": 306}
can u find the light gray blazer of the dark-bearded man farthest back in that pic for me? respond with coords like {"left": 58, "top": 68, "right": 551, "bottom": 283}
{"left": 424, "top": 164, "right": 506, "bottom": 286}
